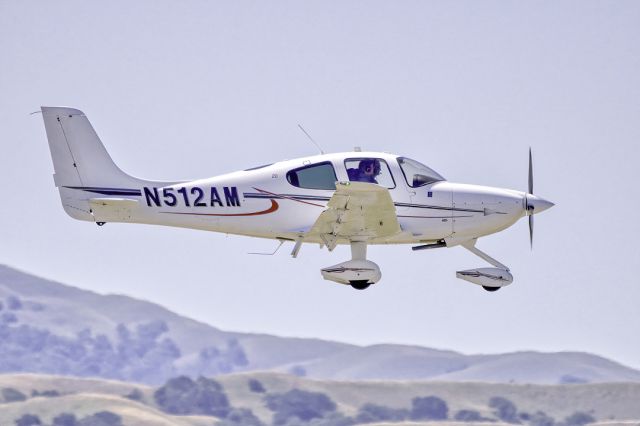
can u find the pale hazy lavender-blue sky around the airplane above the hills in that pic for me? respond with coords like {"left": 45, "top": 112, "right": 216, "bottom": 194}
{"left": 0, "top": 0, "right": 640, "bottom": 368}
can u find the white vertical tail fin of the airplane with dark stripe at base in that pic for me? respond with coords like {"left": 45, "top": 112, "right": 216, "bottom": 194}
{"left": 41, "top": 106, "right": 143, "bottom": 221}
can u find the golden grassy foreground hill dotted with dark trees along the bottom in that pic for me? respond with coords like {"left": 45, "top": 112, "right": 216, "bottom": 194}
{"left": 0, "top": 372, "right": 640, "bottom": 426}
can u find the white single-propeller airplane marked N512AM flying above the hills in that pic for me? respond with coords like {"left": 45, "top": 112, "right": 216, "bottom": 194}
{"left": 41, "top": 107, "right": 554, "bottom": 291}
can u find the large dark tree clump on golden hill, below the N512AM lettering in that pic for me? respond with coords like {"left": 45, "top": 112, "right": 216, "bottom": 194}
{"left": 153, "top": 376, "right": 230, "bottom": 418}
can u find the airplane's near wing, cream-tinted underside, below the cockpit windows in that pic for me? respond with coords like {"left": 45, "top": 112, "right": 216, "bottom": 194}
{"left": 307, "top": 182, "right": 401, "bottom": 250}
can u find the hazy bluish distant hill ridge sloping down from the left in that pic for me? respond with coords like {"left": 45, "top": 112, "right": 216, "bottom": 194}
{"left": 0, "top": 265, "right": 640, "bottom": 384}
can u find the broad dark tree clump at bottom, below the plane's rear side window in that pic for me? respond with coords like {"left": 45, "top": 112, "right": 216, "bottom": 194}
{"left": 265, "top": 389, "right": 336, "bottom": 425}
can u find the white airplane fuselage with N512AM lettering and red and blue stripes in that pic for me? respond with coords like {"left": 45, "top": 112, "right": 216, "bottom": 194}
{"left": 61, "top": 152, "right": 526, "bottom": 244}
